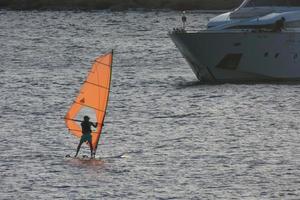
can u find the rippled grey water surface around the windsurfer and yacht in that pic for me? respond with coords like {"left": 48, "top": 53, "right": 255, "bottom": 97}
{"left": 0, "top": 11, "right": 300, "bottom": 200}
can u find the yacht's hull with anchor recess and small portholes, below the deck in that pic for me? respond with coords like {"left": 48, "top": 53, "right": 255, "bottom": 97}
{"left": 170, "top": 31, "right": 300, "bottom": 82}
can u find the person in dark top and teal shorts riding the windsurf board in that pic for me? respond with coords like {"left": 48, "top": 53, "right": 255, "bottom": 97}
{"left": 75, "top": 116, "right": 98, "bottom": 158}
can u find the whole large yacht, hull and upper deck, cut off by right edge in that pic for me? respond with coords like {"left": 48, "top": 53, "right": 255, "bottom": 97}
{"left": 170, "top": 0, "right": 300, "bottom": 82}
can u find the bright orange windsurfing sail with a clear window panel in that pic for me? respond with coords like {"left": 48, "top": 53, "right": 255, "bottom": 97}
{"left": 65, "top": 52, "right": 113, "bottom": 152}
